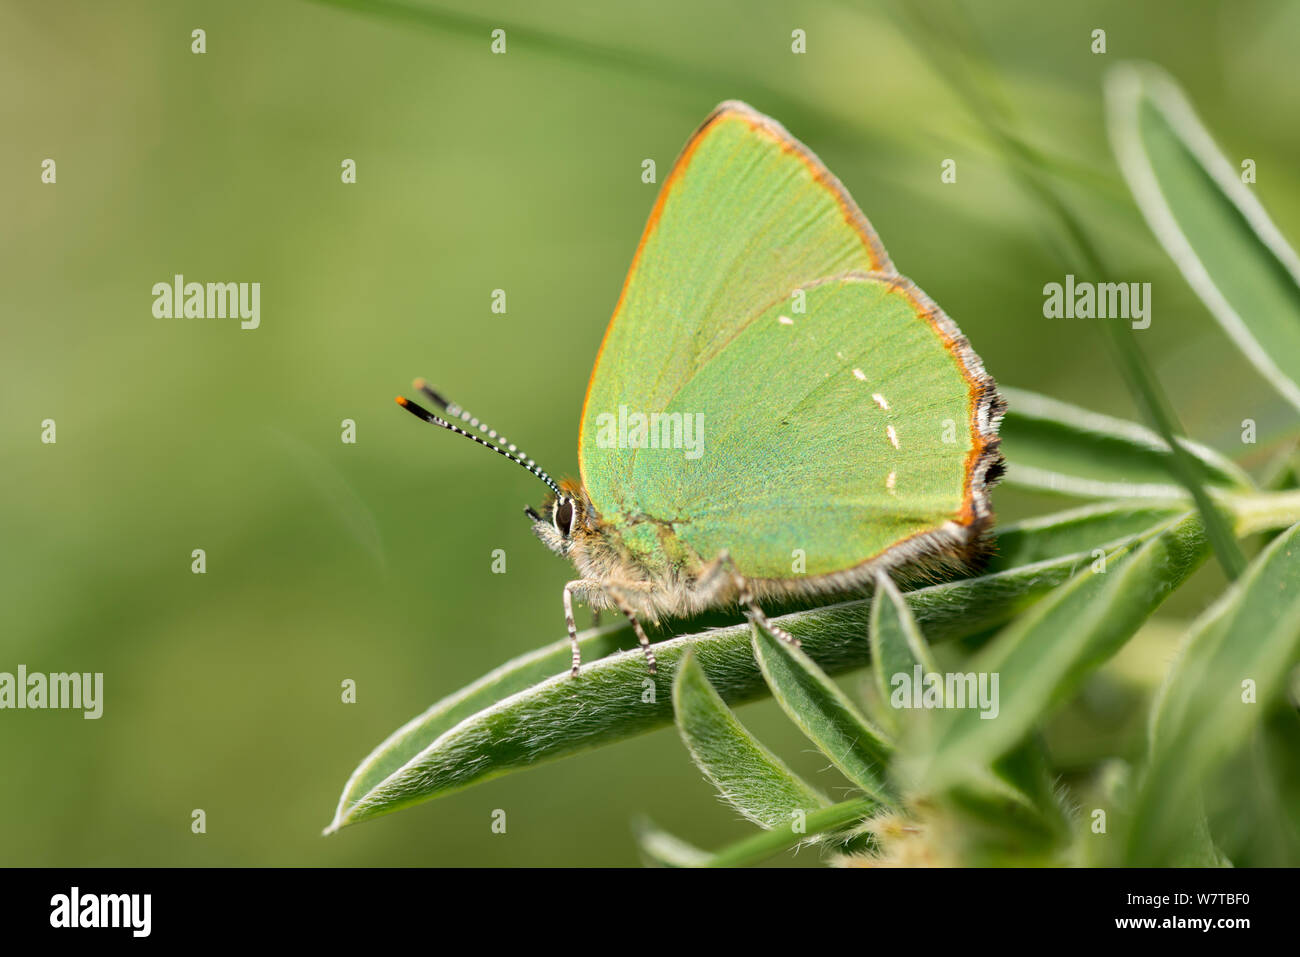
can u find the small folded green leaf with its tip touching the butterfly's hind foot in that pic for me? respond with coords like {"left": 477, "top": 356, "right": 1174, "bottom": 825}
{"left": 753, "top": 625, "right": 891, "bottom": 804}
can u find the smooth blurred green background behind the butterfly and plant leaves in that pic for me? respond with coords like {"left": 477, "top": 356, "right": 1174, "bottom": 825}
{"left": 0, "top": 0, "right": 1300, "bottom": 865}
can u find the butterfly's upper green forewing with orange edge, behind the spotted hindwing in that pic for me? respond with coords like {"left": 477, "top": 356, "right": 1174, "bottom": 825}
{"left": 579, "top": 103, "right": 893, "bottom": 514}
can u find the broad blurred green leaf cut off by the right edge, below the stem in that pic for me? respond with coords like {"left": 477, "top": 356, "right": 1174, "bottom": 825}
{"left": 1127, "top": 524, "right": 1300, "bottom": 865}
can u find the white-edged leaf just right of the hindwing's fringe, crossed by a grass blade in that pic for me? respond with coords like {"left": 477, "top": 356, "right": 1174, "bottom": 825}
{"left": 1000, "top": 387, "right": 1252, "bottom": 498}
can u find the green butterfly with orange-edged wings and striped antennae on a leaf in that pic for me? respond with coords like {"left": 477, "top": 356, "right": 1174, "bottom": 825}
{"left": 398, "top": 101, "right": 1005, "bottom": 676}
